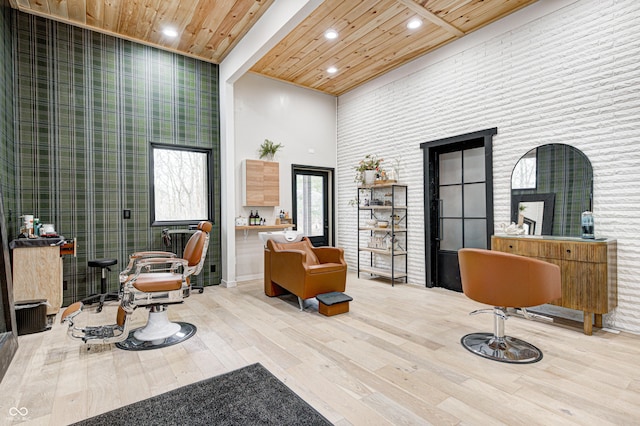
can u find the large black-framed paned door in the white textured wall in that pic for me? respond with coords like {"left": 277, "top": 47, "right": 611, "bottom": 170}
{"left": 420, "top": 128, "right": 498, "bottom": 291}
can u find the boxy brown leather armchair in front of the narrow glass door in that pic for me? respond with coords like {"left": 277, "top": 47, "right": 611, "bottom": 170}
{"left": 264, "top": 237, "right": 347, "bottom": 310}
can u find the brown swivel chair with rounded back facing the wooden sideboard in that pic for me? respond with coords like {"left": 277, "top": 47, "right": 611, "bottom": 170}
{"left": 458, "top": 248, "right": 561, "bottom": 364}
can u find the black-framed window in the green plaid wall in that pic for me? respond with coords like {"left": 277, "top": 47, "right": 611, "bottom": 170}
{"left": 149, "top": 144, "right": 212, "bottom": 225}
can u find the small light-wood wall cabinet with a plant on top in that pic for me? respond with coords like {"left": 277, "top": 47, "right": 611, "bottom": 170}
{"left": 242, "top": 160, "right": 280, "bottom": 207}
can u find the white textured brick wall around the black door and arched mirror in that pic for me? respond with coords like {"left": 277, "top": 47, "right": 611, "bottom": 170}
{"left": 337, "top": 0, "right": 640, "bottom": 333}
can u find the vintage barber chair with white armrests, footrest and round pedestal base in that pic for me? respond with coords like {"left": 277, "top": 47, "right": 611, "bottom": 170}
{"left": 61, "top": 222, "right": 213, "bottom": 350}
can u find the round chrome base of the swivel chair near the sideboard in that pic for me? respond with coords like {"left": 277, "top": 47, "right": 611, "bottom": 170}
{"left": 460, "top": 333, "right": 542, "bottom": 364}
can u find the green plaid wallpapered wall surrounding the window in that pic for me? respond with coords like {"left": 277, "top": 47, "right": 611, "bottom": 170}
{"left": 13, "top": 12, "right": 221, "bottom": 304}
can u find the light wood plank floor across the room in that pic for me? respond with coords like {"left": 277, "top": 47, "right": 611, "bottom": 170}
{"left": 0, "top": 275, "right": 640, "bottom": 425}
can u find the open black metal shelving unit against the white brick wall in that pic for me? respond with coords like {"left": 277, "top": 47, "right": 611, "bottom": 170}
{"left": 358, "top": 183, "right": 408, "bottom": 286}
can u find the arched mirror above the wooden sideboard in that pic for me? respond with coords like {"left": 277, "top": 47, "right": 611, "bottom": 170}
{"left": 511, "top": 144, "right": 593, "bottom": 237}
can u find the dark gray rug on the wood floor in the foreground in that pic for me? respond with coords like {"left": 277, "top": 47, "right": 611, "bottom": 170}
{"left": 75, "top": 364, "right": 331, "bottom": 426}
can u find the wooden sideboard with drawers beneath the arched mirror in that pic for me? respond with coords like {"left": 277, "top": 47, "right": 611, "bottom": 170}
{"left": 491, "top": 235, "right": 618, "bottom": 335}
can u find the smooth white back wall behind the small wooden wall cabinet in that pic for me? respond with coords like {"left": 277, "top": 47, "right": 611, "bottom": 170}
{"left": 234, "top": 74, "right": 336, "bottom": 281}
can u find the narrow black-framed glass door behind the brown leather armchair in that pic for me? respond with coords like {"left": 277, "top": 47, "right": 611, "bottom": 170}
{"left": 291, "top": 164, "right": 335, "bottom": 247}
